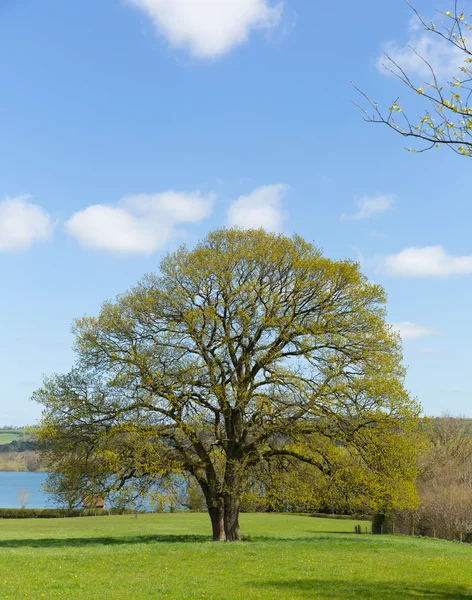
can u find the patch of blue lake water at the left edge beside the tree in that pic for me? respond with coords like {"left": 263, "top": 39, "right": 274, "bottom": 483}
{"left": 0, "top": 471, "right": 52, "bottom": 508}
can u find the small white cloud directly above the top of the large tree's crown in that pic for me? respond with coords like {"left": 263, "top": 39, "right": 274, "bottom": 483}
{"left": 228, "top": 183, "right": 289, "bottom": 232}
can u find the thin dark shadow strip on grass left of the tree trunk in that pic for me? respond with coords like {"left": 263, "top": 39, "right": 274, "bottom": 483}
{"left": 0, "top": 534, "right": 211, "bottom": 549}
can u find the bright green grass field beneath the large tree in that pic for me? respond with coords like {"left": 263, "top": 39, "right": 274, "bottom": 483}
{"left": 0, "top": 514, "right": 472, "bottom": 600}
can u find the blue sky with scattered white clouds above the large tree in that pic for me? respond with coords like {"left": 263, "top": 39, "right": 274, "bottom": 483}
{"left": 0, "top": 0, "right": 472, "bottom": 425}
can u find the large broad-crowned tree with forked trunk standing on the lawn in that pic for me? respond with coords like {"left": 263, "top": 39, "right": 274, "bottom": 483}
{"left": 35, "top": 229, "right": 419, "bottom": 540}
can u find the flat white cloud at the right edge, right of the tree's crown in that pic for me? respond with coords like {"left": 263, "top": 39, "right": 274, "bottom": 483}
{"left": 380, "top": 246, "right": 472, "bottom": 277}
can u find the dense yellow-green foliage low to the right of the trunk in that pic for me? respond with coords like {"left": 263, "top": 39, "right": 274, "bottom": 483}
{"left": 243, "top": 430, "right": 426, "bottom": 514}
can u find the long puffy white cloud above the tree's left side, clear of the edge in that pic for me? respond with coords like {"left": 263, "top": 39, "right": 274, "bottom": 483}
{"left": 65, "top": 190, "right": 214, "bottom": 254}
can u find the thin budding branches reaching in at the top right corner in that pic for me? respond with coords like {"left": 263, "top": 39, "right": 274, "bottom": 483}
{"left": 356, "top": 0, "right": 472, "bottom": 158}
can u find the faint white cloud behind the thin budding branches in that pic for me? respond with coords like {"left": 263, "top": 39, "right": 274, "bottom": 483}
{"left": 377, "top": 18, "right": 464, "bottom": 80}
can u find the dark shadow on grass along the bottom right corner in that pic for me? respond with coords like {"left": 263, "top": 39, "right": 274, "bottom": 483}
{"left": 253, "top": 578, "right": 472, "bottom": 600}
